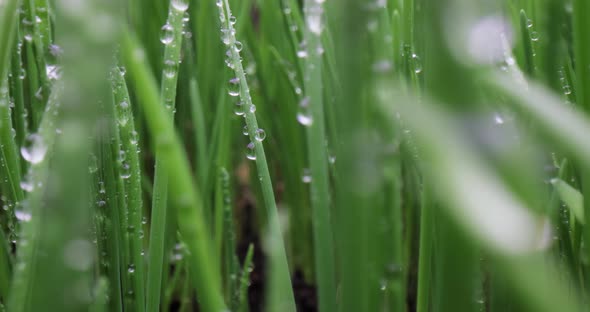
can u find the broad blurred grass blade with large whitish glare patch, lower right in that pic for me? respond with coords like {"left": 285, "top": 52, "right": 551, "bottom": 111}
{"left": 392, "top": 91, "right": 579, "bottom": 312}
